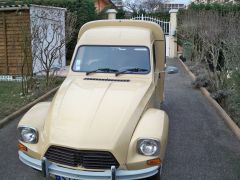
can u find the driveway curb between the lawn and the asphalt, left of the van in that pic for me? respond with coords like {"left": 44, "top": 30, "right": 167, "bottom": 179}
{"left": 0, "top": 86, "right": 60, "bottom": 129}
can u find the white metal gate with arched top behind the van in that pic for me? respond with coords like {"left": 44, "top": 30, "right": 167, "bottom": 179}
{"left": 132, "top": 14, "right": 170, "bottom": 56}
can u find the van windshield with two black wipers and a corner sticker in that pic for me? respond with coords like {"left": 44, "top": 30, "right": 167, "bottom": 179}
{"left": 72, "top": 45, "right": 150, "bottom": 74}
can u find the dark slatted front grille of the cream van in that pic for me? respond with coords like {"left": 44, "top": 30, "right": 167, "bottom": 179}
{"left": 45, "top": 146, "right": 119, "bottom": 169}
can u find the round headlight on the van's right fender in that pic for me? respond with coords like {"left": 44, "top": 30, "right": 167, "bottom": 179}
{"left": 137, "top": 139, "right": 160, "bottom": 156}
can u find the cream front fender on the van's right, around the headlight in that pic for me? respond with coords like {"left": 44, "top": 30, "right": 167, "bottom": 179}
{"left": 127, "top": 109, "right": 169, "bottom": 169}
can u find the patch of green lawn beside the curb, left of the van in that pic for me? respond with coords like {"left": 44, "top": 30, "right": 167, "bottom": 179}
{"left": 0, "top": 79, "right": 63, "bottom": 121}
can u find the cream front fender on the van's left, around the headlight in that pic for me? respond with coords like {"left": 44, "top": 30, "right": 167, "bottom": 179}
{"left": 18, "top": 102, "right": 50, "bottom": 159}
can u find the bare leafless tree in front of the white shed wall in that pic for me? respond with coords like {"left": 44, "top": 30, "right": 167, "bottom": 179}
{"left": 32, "top": 22, "right": 65, "bottom": 86}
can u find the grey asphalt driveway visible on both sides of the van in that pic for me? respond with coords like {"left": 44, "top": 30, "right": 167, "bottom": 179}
{"left": 0, "top": 60, "right": 240, "bottom": 180}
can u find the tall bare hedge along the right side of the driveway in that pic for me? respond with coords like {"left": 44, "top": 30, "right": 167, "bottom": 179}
{"left": 178, "top": 9, "right": 240, "bottom": 125}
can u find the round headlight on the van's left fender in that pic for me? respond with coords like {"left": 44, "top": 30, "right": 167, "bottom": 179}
{"left": 18, "top": 126, "right": 38, "bottom": 144}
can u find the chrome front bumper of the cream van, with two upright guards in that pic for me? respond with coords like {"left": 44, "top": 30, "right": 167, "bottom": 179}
{"left": 18, "top": 151, "right": 160, "bottom": 180}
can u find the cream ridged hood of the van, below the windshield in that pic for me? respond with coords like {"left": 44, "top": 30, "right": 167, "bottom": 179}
{"left": 43, "top": 79, "right": 152, "bottom": 164}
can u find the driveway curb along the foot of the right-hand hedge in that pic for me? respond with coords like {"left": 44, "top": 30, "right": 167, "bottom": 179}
{"left": 179, "top": 59, "right": 240, "bottom": 140}
